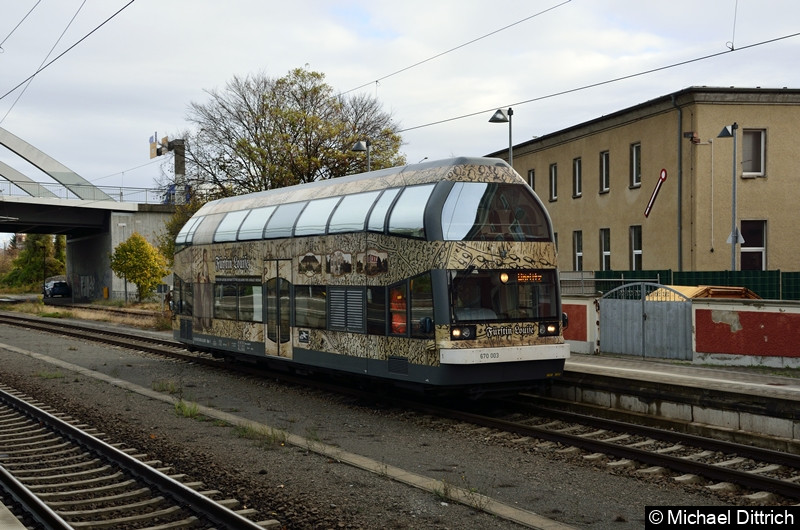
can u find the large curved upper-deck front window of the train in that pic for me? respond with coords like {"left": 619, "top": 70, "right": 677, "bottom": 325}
{"left": 442, "top": 182, "right": 550, "bottom": 241}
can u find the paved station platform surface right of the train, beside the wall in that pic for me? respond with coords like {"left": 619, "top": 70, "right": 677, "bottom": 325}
{"left": 564, "top": 353, "right": 800, "bottom": 402}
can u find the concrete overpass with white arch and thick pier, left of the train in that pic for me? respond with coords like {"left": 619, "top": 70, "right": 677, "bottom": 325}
{"left": 0, "top": 128, "right": 175, "bottom": 299}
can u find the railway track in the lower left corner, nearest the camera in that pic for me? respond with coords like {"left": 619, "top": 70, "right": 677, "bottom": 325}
{"left": 0, "top": 386, "right": 278, "bottom": 529}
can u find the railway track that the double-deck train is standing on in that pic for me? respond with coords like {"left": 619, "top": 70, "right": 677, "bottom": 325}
{"left": 0, "top": 308, "right": 800, "bottom": 503}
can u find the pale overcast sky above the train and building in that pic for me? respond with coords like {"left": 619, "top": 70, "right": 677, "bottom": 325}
{"left": 0, "top": 0, "right": 800, "bottom": 194}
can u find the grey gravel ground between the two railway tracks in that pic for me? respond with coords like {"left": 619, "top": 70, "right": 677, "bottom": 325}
{"left": 0, "top": 316, "right": 736, "bottom": 530}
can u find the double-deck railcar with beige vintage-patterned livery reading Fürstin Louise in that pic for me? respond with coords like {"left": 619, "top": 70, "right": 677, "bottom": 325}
{"left": 173, "top": 157, "right": 569, "bottom": 394}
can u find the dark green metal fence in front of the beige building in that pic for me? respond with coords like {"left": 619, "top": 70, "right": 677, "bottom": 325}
{"left": 561, "top": 270, "right": 800, "bottom": 300}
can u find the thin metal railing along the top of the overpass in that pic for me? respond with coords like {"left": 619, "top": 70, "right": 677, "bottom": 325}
{"left": 0, "top": 180, "right": 166, "bottom": 204}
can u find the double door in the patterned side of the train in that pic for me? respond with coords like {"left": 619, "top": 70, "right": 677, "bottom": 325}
{"left": 264, "top": 259, "right": 292, "bottom": 359}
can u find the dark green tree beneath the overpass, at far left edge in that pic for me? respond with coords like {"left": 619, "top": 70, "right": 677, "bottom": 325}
{"left": 3, "top": 234, "right": 66, "bottom": 288}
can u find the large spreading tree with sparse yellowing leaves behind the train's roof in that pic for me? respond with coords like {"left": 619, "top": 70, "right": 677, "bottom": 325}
{"left": 179, "top": 68, "right": 405, "bottom": 197}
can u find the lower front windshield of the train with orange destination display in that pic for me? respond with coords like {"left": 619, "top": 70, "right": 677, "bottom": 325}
{"left": 450, "top": 269, "right": 560, "bottom": 322}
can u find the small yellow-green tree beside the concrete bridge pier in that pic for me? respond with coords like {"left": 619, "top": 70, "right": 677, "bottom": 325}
{"left": 111, "top": 232, "right": 169, "bottom": 302}
